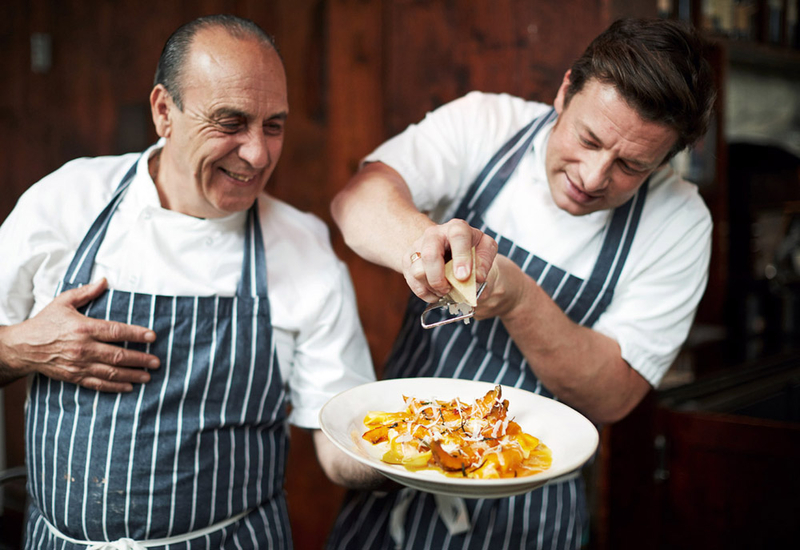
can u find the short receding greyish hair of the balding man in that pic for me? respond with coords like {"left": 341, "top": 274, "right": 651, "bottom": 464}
{"left": 153, "top": 14, "right": 280, "bottom": 111}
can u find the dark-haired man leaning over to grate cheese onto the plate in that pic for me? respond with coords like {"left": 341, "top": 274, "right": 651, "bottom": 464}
{"left": 329, "top": 16, "right": 715, "bottom": 549}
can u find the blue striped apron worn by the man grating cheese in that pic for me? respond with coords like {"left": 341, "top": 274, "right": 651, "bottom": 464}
{"left": 328, "top": 109, "right": 647, "bottom": 550}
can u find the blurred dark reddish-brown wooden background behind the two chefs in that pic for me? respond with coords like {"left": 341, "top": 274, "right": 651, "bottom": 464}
{"left": 0, "top": 0, "right": 800, "bottom": 550}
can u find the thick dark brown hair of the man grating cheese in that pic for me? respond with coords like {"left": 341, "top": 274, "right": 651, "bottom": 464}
{"left": 564, "top": 19, "right": 716, "bottom": 161}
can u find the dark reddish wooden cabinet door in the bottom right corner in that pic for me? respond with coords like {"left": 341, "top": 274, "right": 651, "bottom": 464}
{"left": 662, "top": 412, "right": 800, "bottom": 550}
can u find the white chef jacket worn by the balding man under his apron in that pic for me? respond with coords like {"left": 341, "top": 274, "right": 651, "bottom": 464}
{"left": 0, "top": 146, "right": 375, "bottom": 428}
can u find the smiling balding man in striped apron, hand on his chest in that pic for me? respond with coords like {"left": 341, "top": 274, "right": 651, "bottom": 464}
{"left": 0, "top": 12, "right": 379, "bottom": 550}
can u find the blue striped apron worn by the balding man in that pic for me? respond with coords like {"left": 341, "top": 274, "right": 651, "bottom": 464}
{"left": 25, "top": 164, "right": 291, "bottom": 550}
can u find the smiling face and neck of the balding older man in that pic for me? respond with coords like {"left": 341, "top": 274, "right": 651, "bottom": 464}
{"left": 150, "top": 28, "right": 289, "bottom": 218}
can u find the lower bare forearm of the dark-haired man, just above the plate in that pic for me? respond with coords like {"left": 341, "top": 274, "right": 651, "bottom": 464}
{"left": 501, "top": 271, "right": 650, "bottom": 423}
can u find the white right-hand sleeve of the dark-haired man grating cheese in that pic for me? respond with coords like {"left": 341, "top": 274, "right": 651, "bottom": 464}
{"left": 593, "top": 185, "right": 712, "bottom": 387}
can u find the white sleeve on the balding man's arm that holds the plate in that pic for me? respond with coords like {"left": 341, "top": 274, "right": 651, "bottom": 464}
{"left": 260, "top": 204, "right": 375, "bottom": 428}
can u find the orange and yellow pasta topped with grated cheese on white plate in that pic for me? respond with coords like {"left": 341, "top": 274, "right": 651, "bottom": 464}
{"left": 361, "top": 386, "right": 552, "bottom": 479}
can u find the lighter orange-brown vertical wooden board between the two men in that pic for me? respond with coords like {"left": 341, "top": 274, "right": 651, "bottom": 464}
{"left": 327, "top": 0, "right": 408, "bottom": 374}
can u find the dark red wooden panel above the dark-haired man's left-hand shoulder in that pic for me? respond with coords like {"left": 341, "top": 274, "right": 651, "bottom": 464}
{"left": 386, "top": 0, "right": 606, "bottom": 134}
